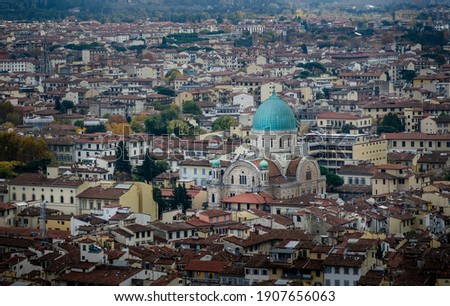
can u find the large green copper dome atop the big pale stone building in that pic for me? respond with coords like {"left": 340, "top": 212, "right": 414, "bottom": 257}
{"left": 253, "top": 92, "right": 297, "bottom": 131}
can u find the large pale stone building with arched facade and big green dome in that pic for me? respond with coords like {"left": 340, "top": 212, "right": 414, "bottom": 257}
{"left": 208, "top": 92, "right": 325, "bottom": 209}
